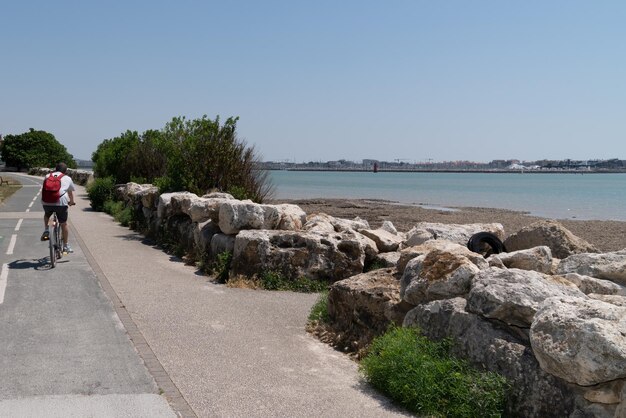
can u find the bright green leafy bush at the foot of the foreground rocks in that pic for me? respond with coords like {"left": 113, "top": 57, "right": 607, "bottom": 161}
{"left": 360, "top": 328, "right": 508, "bottom": 417}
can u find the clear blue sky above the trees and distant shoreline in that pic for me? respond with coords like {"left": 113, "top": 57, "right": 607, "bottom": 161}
{"left": 0, "top": 0, "right": 626, "bottom": 162}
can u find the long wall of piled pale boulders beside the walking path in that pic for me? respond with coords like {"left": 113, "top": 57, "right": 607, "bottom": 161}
{"left": 112, "top": 183, "right": 626, "bottom": 418}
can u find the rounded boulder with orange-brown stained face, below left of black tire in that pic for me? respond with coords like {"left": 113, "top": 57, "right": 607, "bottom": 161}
{"left": 400, "top": 250, "right": 480, "bottom": 305}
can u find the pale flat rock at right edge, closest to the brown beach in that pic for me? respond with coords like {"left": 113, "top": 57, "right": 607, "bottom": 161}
{"left": 557, "top": 250, "right": 626, "bottom": 286}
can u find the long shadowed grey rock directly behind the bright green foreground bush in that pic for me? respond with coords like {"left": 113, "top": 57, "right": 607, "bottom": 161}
{"left": 404, "top": 298, "right": 576, "bottom": 418}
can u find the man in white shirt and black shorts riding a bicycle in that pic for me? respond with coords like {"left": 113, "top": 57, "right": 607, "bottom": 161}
{"left": 41, "top": 163, "right": 76, "bottom": 253}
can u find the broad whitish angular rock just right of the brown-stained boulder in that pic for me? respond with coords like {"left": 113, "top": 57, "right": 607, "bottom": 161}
{"left": 467, "top": 267, "right": 586, "bottom": 328}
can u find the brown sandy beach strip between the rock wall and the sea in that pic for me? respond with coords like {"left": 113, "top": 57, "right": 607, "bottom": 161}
{"left": 275, "top": 199, "right": 626, "bottom": 252}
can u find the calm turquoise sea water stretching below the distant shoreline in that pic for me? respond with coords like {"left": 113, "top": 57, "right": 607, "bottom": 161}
{"left": 270, "top": 171, "right": 626, "bottom": 221}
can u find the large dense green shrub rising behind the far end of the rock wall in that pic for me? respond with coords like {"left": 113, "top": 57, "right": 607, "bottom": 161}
{"left": 92, "top": 116, "right": 273, "bottom": 202}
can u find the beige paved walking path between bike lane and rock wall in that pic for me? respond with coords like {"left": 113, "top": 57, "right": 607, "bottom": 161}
{"left": 63, "top": 179, "right": 405, "bottom": 417}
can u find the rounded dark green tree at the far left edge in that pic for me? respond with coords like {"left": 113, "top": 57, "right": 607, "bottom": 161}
{"left": 1, "top": 128, "right": 76, "bottom": 170}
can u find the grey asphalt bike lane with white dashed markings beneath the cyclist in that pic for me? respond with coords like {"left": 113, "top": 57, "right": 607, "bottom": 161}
{"left": 0, "top": 175, "right": 175, "bottom": 417}
